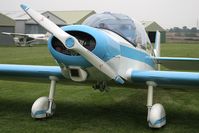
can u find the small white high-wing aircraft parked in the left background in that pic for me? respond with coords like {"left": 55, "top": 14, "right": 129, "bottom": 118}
{"left": 1, "top": 32, "right": 51, "bottom": 47}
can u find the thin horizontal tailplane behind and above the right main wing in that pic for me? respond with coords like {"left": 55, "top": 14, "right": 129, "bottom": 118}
{"left": 153, "top": 57, "right": 199, "bottom": 71}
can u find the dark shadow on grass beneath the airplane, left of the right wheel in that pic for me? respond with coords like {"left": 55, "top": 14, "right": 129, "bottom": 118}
{"left": 0, "top": 99, "right": 148, "bottom": 128}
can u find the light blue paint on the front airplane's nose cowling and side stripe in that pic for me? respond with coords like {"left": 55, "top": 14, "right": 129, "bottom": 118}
{"left": 48, "top": 25, "right": 155, "bottom": 67}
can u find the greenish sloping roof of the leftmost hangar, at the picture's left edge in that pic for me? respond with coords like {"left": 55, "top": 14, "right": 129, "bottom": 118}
{"left": 0, "top": 13, "right": 15, "bottom": 26}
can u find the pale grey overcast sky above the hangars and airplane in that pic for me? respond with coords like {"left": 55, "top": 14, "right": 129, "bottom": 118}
{"left": 0, "top": 0, "right": 199, "bottom": 29}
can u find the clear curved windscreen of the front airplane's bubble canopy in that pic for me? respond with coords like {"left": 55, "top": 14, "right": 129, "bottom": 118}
{"left": 83, "top": 12, "right": 136, "bottom": 43}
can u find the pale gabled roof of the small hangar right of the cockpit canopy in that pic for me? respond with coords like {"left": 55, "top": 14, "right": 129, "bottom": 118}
{"left": 141, "top": 21, "right": 165, "bottom": 31}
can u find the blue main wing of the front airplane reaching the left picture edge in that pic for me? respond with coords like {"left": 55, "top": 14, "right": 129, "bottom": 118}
{"left": 0, "top": 64, "right": 64, "bottom": 80}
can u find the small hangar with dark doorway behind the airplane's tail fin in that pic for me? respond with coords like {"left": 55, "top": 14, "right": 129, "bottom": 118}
{"left": 141, "top": 21, "right": 166, "bottom": 43}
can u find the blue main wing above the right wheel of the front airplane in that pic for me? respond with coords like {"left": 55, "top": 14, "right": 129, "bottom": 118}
{"left": 130, "top": 71, "right": 199, "bottom": 87}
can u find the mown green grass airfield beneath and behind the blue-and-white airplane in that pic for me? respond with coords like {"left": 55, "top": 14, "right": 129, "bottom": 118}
{"left": 0, "top": 44, "right": 199, "bottom": 133}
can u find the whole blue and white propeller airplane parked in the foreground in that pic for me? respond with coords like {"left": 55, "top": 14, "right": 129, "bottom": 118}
{"left": 0, "top": 5, "right": 199, "bottom": 128}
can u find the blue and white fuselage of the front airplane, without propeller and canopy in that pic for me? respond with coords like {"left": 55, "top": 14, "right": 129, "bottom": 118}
{"left": 48, "top": 25, "right": 156, "bottom": 81}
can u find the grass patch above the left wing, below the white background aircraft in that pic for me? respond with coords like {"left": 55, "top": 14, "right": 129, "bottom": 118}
{"left": 0, "top": 45, "right": 56, "bottom": 65}
